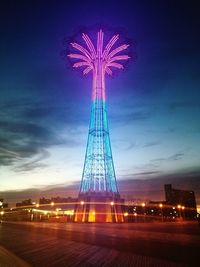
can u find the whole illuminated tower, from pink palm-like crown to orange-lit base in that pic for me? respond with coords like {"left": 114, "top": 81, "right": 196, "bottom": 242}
{"left": 68, "top": 30, "right": 129, "bottom": 221}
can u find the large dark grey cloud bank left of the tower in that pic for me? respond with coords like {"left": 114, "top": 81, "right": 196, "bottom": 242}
{"left": 0, "top": 103, "right": 79, "bottom": 170}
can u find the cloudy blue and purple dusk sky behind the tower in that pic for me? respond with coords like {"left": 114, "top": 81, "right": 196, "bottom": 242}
{"left": 0, "top": 0, "right": 200, "bottom": 207}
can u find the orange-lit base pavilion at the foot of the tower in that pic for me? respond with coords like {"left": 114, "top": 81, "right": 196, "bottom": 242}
{"left": 74, "top": 192, "right": 124, "bottom": 223}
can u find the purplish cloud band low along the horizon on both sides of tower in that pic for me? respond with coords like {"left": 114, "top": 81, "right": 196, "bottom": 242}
{"left": 0, "top": 173, "right": 200, "bottom": 211}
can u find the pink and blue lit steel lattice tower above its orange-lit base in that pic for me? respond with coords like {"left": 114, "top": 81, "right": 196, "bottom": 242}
{"left": 68, "top": 30, "right": 129, "bottom": 222}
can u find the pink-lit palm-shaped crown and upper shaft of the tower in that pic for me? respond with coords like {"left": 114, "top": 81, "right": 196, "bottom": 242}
{"left": 68, "top": 30, "right": 130, "bottom": 101}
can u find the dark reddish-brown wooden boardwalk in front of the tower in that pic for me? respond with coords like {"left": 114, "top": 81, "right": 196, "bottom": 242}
{"left": 0, "top": 222, "right": 200, "bottom": 267}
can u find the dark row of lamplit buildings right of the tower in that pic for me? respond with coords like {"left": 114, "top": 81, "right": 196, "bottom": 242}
{"left": 124, "top": 184, "right": 197, "bottom": 222}
